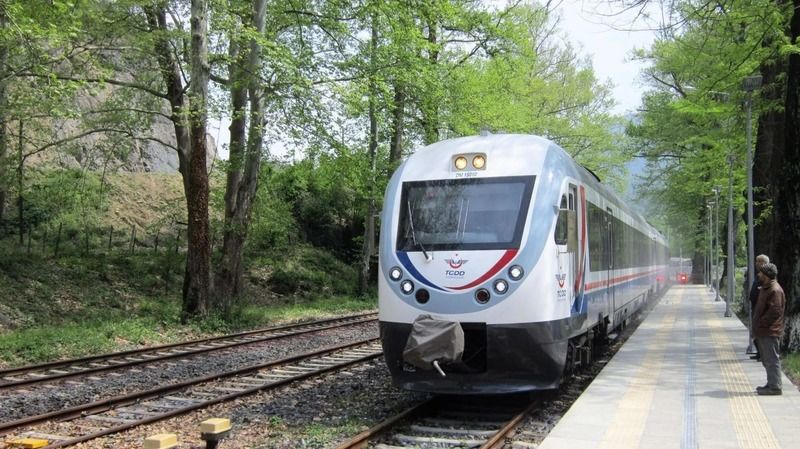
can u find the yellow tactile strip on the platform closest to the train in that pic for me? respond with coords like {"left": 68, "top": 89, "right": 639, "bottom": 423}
{"left": 598, "top": 290, "right": 683, "bottom": 449}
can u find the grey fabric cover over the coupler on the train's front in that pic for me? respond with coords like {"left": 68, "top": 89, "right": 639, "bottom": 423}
{"left": 403, "top": 315, "right": 464, "bottom": 370}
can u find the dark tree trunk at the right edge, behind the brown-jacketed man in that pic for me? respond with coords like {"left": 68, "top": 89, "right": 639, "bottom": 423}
{"left": 772, "top": 0, "right": 800, "bottom": 352}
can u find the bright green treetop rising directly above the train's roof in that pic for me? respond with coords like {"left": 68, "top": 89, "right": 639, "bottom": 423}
{"left": 443, "top": 5, "right": 625, "bottom": 178}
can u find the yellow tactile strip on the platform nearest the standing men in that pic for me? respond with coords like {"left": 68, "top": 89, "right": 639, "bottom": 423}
{"left": 703, "top": 304, "right": 781, "bottom": 449}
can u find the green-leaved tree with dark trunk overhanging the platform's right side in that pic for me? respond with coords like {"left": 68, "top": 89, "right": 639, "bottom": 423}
{"left": 620, "top": 0, "right": 800, "bottom": 351}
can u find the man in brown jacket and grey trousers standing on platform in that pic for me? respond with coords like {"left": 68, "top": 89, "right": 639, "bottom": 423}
{"left": 753, "top": 263, "right": 786, "bottom": 396}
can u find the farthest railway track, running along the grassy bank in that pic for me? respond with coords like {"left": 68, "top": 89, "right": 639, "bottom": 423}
{"left": 0, "top": 313, "right": 377, "bottom": 391}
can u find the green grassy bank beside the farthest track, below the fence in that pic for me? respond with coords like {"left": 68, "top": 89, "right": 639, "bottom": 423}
{"left": 0, "top": 242, "right": 376, "bottom": 367}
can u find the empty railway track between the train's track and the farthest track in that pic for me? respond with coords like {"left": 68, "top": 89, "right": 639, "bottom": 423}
{"left": 0, "top": 338, "right": 383, "bottom": 449}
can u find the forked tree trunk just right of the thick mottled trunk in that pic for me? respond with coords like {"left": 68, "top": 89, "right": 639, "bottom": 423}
{"left": 214, "top": 0, "right": 266, "bottom": 310}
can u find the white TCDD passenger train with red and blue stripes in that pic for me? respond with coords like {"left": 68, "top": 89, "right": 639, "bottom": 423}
{"left": 378, "top": 133, "right": 668, "bottom": 394}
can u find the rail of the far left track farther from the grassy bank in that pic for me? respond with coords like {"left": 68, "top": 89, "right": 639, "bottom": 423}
{"left": 0, "top": 314, "right": 374, "bottom": 391}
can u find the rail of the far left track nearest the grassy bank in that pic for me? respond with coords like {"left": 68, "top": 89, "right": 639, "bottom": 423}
{"left": 0, "top": 312, "right": 377, "bottom": 377}
